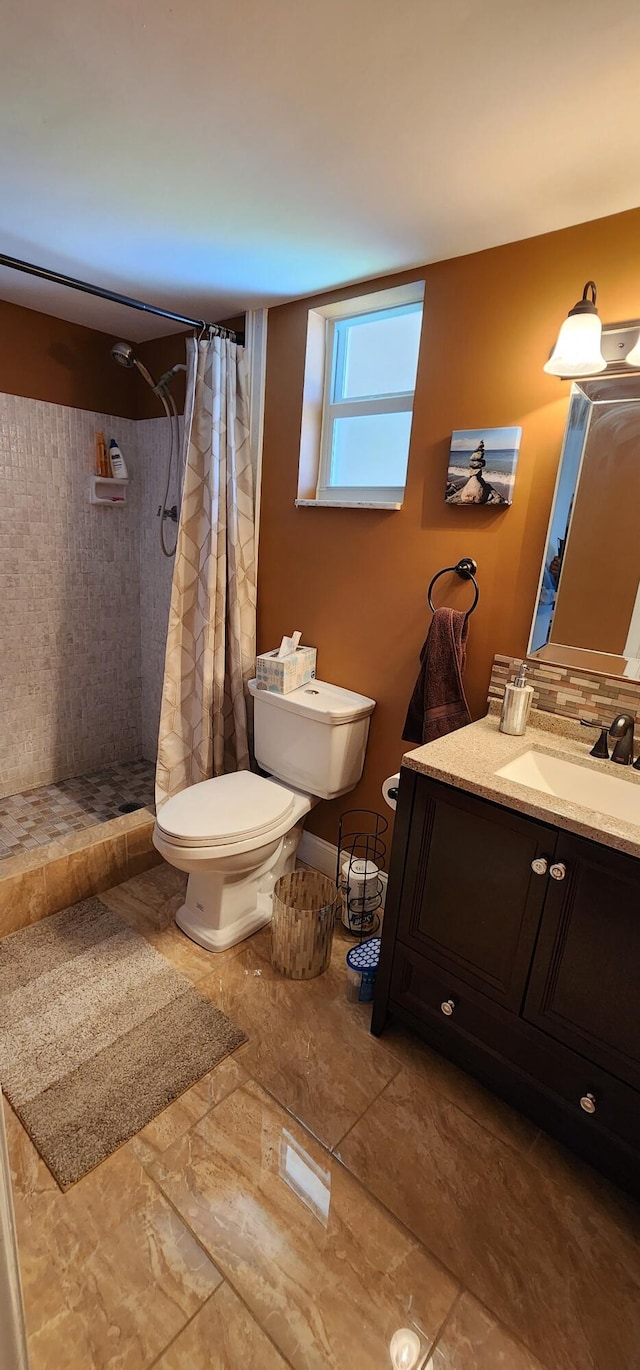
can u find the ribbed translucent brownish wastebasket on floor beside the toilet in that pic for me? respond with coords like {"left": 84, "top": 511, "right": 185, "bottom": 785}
{"left": 271, "top": 870, "right": 337, "bottom": 980}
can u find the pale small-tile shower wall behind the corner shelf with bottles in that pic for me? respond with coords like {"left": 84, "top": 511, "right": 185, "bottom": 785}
{"left": 0, "top": 395, "right": 175, "bottom": 795}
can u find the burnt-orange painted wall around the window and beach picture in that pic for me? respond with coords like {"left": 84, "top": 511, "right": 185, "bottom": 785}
{"left": 259, "top": 210, "right": 640, "bottom": 840}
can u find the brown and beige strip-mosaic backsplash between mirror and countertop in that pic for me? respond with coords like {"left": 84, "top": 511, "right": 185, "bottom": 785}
{"left": 489, "top": 656, "right": 640, "bottom": 722}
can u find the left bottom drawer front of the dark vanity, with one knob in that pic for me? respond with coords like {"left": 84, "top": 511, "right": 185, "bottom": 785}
{"left": 389, "top": 943, "right": 518, "bottom": 1052}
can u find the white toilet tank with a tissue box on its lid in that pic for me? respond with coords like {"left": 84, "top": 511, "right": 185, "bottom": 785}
{"left": 249, "top": 680, "right": 376, "bottom": 799}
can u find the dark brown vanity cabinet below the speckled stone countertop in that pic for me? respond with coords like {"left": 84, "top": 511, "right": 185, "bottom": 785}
{"left": 371, "top": 769, "right": 640, "bottom": 1193}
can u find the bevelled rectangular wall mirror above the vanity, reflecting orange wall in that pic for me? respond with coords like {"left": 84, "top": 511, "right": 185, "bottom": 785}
{"left": 529, "top": 375, "right": 640, "bottom": 680}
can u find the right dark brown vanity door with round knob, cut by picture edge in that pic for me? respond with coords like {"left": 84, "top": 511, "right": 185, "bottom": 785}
{"left": 525, "top": 833, "right": 640, "bottom": 1088}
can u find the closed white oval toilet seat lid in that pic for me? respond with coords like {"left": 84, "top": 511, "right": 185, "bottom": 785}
{"left": 156, "top": 771, "right": 293, "bottom": 847}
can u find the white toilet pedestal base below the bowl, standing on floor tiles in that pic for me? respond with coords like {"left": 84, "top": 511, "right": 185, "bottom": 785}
{"left": 175, "top": 822, "right": 303, "bottom": 952}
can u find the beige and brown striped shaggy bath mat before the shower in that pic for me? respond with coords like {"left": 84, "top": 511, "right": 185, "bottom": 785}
{"left": 0, "top": 899, "right": 247, "bottom": 1189}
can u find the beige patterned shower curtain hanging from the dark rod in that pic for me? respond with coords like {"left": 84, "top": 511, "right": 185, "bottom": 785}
{"left": 156, "top": 337, "right": 256, "bottom": 806}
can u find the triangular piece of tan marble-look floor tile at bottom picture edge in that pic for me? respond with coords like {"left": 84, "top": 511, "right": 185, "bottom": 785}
{"left": 153, "top": 1284, "right": 288, "bottom": 1370}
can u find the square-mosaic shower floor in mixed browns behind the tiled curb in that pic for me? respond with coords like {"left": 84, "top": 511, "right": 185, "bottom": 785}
{"left": 0, "top": 762, "right": 155, "bottom": 860}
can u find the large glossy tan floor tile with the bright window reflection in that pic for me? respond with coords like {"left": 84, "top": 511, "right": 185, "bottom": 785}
{"left": 149, "top": 1081, "right": 458, "bottom": 1370}
